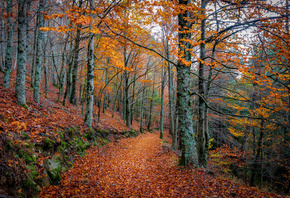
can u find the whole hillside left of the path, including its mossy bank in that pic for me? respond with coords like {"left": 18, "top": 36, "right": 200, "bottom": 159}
{"left": 0, "top": 72, "right": 138, "bottom": 197}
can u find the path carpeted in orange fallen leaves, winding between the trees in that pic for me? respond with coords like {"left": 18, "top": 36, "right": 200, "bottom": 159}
{"left": 39, "top": 132, "right": 282, "bottom": 198}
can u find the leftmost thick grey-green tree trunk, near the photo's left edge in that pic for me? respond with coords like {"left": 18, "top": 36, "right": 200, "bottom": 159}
{"left": 3, "top": 0, "right": 13, "bottom": 88}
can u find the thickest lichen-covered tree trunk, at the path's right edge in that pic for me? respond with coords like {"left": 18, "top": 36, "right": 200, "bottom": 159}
{"left": 176, "top": 0, "right": 198, "bottom": 166}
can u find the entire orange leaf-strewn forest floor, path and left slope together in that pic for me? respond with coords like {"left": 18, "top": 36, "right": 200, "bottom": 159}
{"left": 0, "top": 73, "right": 283, "bottom": 198}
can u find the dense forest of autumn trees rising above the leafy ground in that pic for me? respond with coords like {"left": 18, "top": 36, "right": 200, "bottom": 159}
{"left": 0, "top": 0, "right": 290, "bottom": 197}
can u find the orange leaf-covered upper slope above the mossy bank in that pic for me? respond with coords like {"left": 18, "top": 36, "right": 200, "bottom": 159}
{"left": 0, "top": 71, "right": 139, "bottom": 141}
